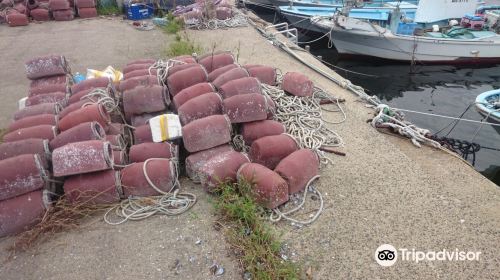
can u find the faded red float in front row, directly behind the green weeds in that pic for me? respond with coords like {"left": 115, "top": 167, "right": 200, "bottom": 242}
{"left": 237, "top": 163, "right": 288, "bottom": 209}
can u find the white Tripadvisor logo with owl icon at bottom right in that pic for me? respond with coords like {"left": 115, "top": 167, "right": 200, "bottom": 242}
{"left": 375, "top": 244, "right": 481, "bottom": 266}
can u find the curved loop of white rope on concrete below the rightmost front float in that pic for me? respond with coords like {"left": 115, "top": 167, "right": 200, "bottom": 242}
{"left": 269, "top": 175, "right": 324, "bottom": 225}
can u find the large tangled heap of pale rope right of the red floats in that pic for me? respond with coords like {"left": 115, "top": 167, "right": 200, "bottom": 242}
{"left": 262, "top": 84, "right": 344, "bottom": 164}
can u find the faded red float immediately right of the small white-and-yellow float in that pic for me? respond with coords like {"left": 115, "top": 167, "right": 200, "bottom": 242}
{"left": 182, "top": 115, "right": 231, "bottom": 153}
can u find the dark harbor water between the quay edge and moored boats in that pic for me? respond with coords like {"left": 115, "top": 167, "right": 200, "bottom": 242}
{"left": 254, "top": 8, "right": 500, "bottom": 185}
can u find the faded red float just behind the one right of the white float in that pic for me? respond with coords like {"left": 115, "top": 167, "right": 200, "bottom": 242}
{"left": 177, "top": 92, "right": 222, "bottom": 125}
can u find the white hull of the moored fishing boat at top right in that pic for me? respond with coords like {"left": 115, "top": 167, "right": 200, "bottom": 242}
{"left": 317, "top": 17, "right": 500, "bottom": 63}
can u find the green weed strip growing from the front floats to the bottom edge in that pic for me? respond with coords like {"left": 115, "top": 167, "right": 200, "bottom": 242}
{"left": 214, "top": 180, "right": 300, "bottom": 280}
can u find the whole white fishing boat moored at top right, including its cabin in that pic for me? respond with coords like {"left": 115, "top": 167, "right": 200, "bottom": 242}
{"left": 311, "top": 0, "right": 500, "bottom": 64}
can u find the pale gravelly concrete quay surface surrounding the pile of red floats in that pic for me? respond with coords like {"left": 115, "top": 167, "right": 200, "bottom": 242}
{"left": 0, "top": 12, "right": 500, "bottom": 279}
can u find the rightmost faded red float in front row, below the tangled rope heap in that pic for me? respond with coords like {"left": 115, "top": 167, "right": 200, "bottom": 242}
{"left": 274, "top": 149, "right": 319, "bottom": 194}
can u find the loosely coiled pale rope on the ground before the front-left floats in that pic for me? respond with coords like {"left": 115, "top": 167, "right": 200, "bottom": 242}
{"left": 104, "top": 158, "right": 197, "bottom": 225}
